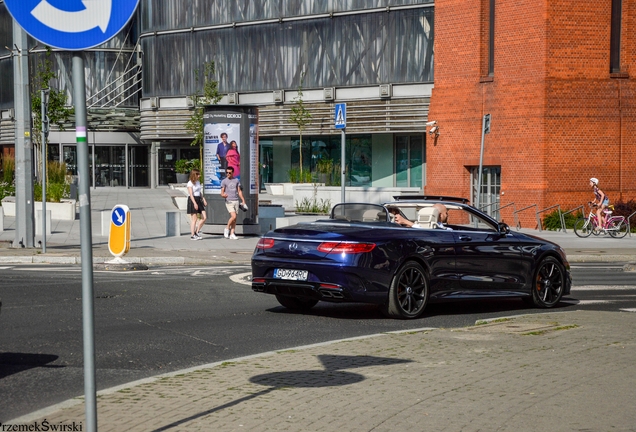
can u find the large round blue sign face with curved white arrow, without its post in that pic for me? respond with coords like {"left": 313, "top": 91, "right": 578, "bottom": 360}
{"left": 4, "top": 0, "right": 139, "bottom": 51}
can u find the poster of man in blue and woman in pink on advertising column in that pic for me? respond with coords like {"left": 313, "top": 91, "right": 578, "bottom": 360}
{"left": 203, "top": 112, "right": 242, "bottom": 194}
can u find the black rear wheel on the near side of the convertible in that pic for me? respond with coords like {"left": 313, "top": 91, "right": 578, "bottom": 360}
{"left": 386, "top": 261, "right": 429, "bottom": 319}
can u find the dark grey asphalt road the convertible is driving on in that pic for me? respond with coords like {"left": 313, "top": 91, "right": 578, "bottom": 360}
{"left": 0, "top": 263, "right": 636, "bottom": 422}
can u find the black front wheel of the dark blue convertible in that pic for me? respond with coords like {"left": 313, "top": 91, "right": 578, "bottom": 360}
{"left": 532, "top": 257, "right": 566, "bottom": 308}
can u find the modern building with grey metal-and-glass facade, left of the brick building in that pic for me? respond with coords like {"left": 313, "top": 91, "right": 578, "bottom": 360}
{"left": 0, "top": 0, "right": 434, "bottom": 188}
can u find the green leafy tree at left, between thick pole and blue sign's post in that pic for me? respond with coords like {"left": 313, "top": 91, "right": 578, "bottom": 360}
{"left": 30, "top": 46, "right": 75, "bottom": 178}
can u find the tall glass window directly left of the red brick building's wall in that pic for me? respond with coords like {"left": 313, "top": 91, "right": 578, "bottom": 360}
{"left": 395, "top": 134, "right": 426, "bottom": 188}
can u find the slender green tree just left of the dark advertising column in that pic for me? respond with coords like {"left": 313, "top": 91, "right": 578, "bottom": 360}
{"left": 185, "top": 61, "right": 222, "bottom": 168}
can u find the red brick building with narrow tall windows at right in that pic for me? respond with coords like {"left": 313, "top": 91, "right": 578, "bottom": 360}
{"left": 426, "top": 0, "right": 636, "bottom": 227}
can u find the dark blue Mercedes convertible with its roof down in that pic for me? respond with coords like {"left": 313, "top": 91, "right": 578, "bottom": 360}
{"left": 252, "top": 197, "right": 571, "bottom": 318}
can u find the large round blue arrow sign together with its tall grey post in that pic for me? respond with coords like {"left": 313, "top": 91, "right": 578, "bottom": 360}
{"left": 4, "top": 0, "right": 139, "bottom": 432}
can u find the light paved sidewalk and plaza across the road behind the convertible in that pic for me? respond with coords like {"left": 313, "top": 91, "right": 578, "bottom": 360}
{"left": 0, "top": 187, "right": 636, "bottom": 265}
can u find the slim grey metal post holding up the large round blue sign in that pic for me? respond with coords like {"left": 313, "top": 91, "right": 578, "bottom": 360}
{"left": 73, "top": 52, "right": 97, "bottom": 432}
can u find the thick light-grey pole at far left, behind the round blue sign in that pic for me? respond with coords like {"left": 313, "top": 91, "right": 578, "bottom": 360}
{"left": 13, "top": 20, "right": 35, "bottom": 248}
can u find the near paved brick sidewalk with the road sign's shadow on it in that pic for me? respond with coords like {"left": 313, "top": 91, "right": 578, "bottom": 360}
{"left": 7, "top": 311, "right": 636, "bottom": 432}
